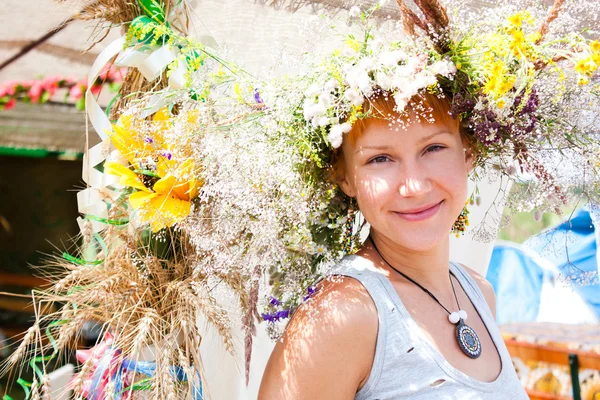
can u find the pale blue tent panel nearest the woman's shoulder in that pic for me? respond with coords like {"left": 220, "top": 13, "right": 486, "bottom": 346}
{"left": 486, "top": 244, "right": 544, "bottom": 324}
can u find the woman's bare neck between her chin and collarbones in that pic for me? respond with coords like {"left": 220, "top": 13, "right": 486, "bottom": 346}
{"left": 358, "top": 231, "right": 450, "bottom": 292}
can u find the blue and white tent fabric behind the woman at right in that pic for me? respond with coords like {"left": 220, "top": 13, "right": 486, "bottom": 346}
{"left": 486, "top": 210, "right": 600, "bottom": 324}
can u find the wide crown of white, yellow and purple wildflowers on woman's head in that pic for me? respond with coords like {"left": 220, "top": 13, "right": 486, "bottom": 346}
{"left": 278, "top": 1, "right": 600, "bottom": 200}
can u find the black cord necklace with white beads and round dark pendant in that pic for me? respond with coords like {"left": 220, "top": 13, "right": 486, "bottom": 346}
{"left": 369, "top": 238, "right": 481, "bottom": 358}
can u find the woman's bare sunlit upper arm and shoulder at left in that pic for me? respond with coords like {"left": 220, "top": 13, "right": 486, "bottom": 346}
{"left": 258, "top": 278, "right": 378, "bottom": 400}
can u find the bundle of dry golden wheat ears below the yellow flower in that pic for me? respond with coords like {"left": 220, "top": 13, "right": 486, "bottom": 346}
{"left": 4, "top": 227, "right": 234, "bottom": 399}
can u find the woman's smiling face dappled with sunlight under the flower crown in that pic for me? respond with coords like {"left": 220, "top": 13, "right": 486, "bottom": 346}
{"left": 340, "top": 119, "right": 472, "bottom": 251}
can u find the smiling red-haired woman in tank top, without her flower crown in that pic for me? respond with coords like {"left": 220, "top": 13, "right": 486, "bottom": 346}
{"left": 259, "top": 88, "right": 526, "bottom": 399}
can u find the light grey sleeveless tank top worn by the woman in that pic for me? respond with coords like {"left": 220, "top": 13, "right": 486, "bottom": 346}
{"left": 331, "top": 255, "right": 528, "bottom": 400}
